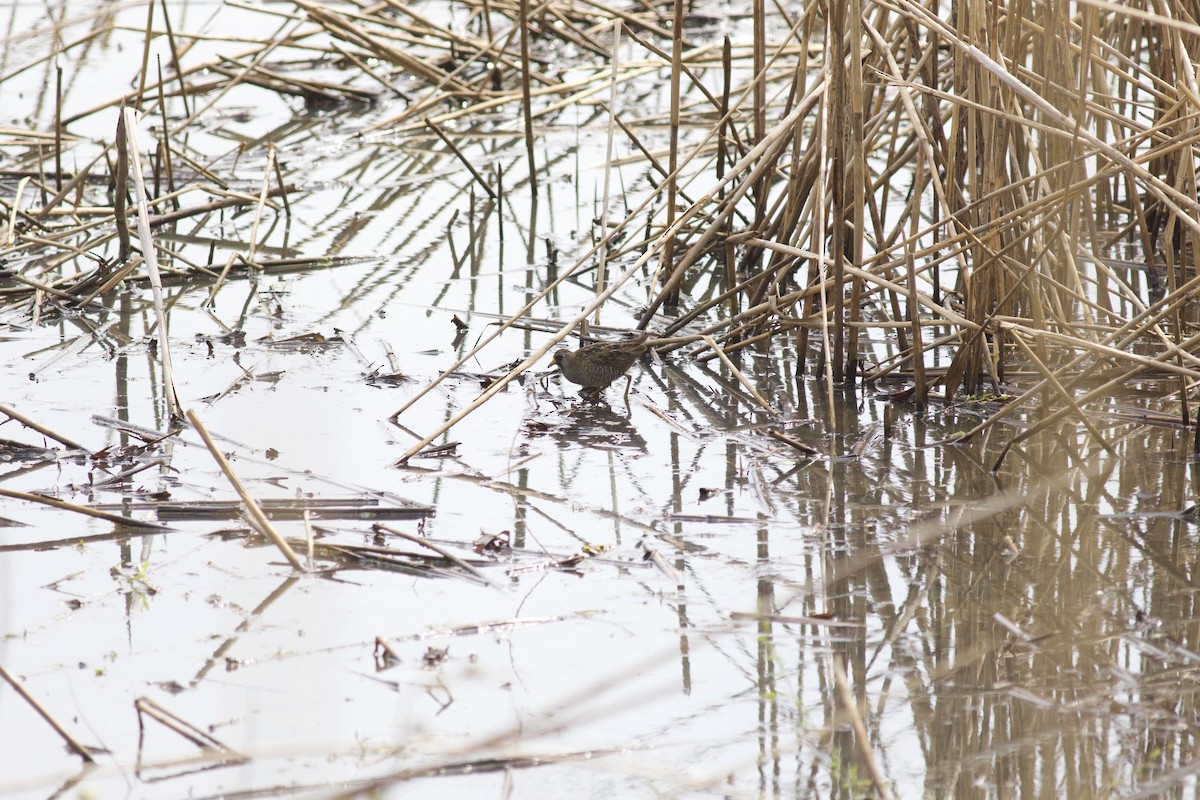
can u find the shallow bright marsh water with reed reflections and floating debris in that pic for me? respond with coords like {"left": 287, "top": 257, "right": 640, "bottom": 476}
{"left": 0, "top": 2, "right": 1200, "bottom": 799}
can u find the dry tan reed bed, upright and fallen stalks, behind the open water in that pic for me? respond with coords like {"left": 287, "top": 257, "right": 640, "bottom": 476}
{"left": 0, "top": 0, "right": 1200, "bottom": 458}
